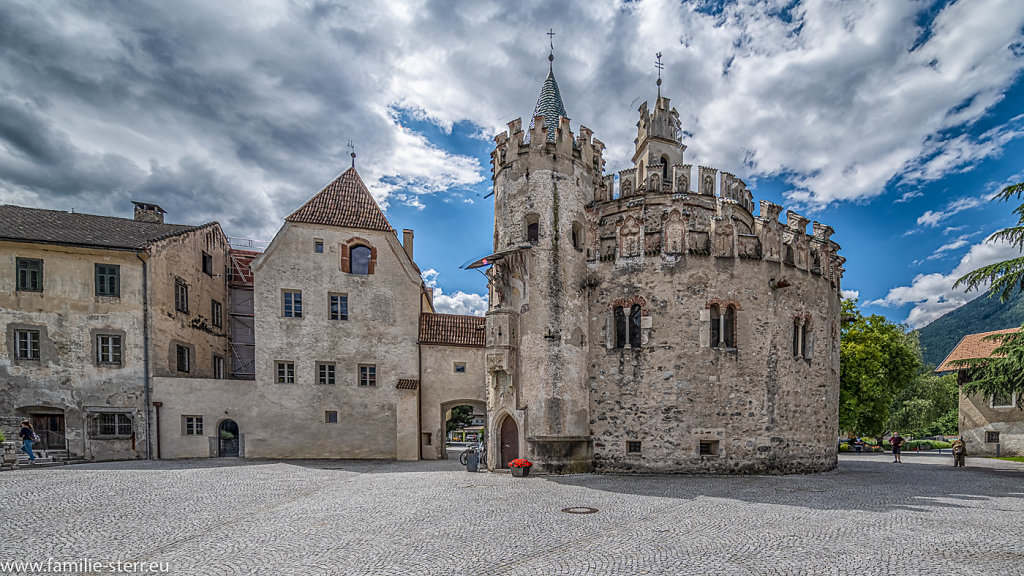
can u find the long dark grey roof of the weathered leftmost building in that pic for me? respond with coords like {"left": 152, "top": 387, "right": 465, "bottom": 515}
{"left": 0, "top": 204, "right": 209, "bottom": 250}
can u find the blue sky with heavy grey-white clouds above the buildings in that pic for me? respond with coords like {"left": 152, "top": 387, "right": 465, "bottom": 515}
{"left": 0, "top": 0, "right": 1024, "bottom": 326}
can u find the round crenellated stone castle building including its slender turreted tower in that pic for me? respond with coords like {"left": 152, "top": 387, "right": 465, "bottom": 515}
{"left": 474, "top": 57, "right": 844, "bottom": 472}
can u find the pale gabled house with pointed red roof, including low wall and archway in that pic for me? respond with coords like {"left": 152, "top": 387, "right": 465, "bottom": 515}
{"left": 154, "top": 167, "right": 484, "bottom": 460}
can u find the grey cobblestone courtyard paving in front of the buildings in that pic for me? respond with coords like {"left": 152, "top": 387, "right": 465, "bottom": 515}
{"left": 0, "top": 454, "right": 1024, "bottom": 576}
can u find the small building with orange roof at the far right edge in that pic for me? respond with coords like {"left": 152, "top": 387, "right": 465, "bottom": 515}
{"left": 935, "top": 328, "right": 1024, "bottom": 456}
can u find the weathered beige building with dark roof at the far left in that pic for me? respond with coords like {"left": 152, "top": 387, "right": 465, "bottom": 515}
{"left": 0, "top": 203, "right": 228, "bottom": 460}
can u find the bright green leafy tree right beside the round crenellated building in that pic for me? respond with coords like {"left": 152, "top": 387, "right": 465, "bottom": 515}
{"left": 839, "top": 300, "right": 921, "bottom": 438}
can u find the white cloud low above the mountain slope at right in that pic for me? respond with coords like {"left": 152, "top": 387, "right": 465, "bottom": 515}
{"left": 868, "top": 234, "right": 1020, "bottom": 328}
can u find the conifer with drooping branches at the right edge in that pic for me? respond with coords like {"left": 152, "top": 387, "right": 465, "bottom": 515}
{"left": 953, "top": 182, "right": 1024, "bottom": 408}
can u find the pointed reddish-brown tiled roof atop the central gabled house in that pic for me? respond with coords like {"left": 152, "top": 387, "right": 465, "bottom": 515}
{"left": 285, "top": 168, "right": 394, "bottom": 232}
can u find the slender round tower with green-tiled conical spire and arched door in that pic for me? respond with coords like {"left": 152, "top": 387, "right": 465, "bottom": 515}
{"left": 486, "top": 56, "right": 605, "bottom": 474}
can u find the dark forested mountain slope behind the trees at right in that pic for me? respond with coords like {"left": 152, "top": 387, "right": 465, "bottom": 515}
{"left": 918, "top": 293, "right": 1024, "bottom": 366}
